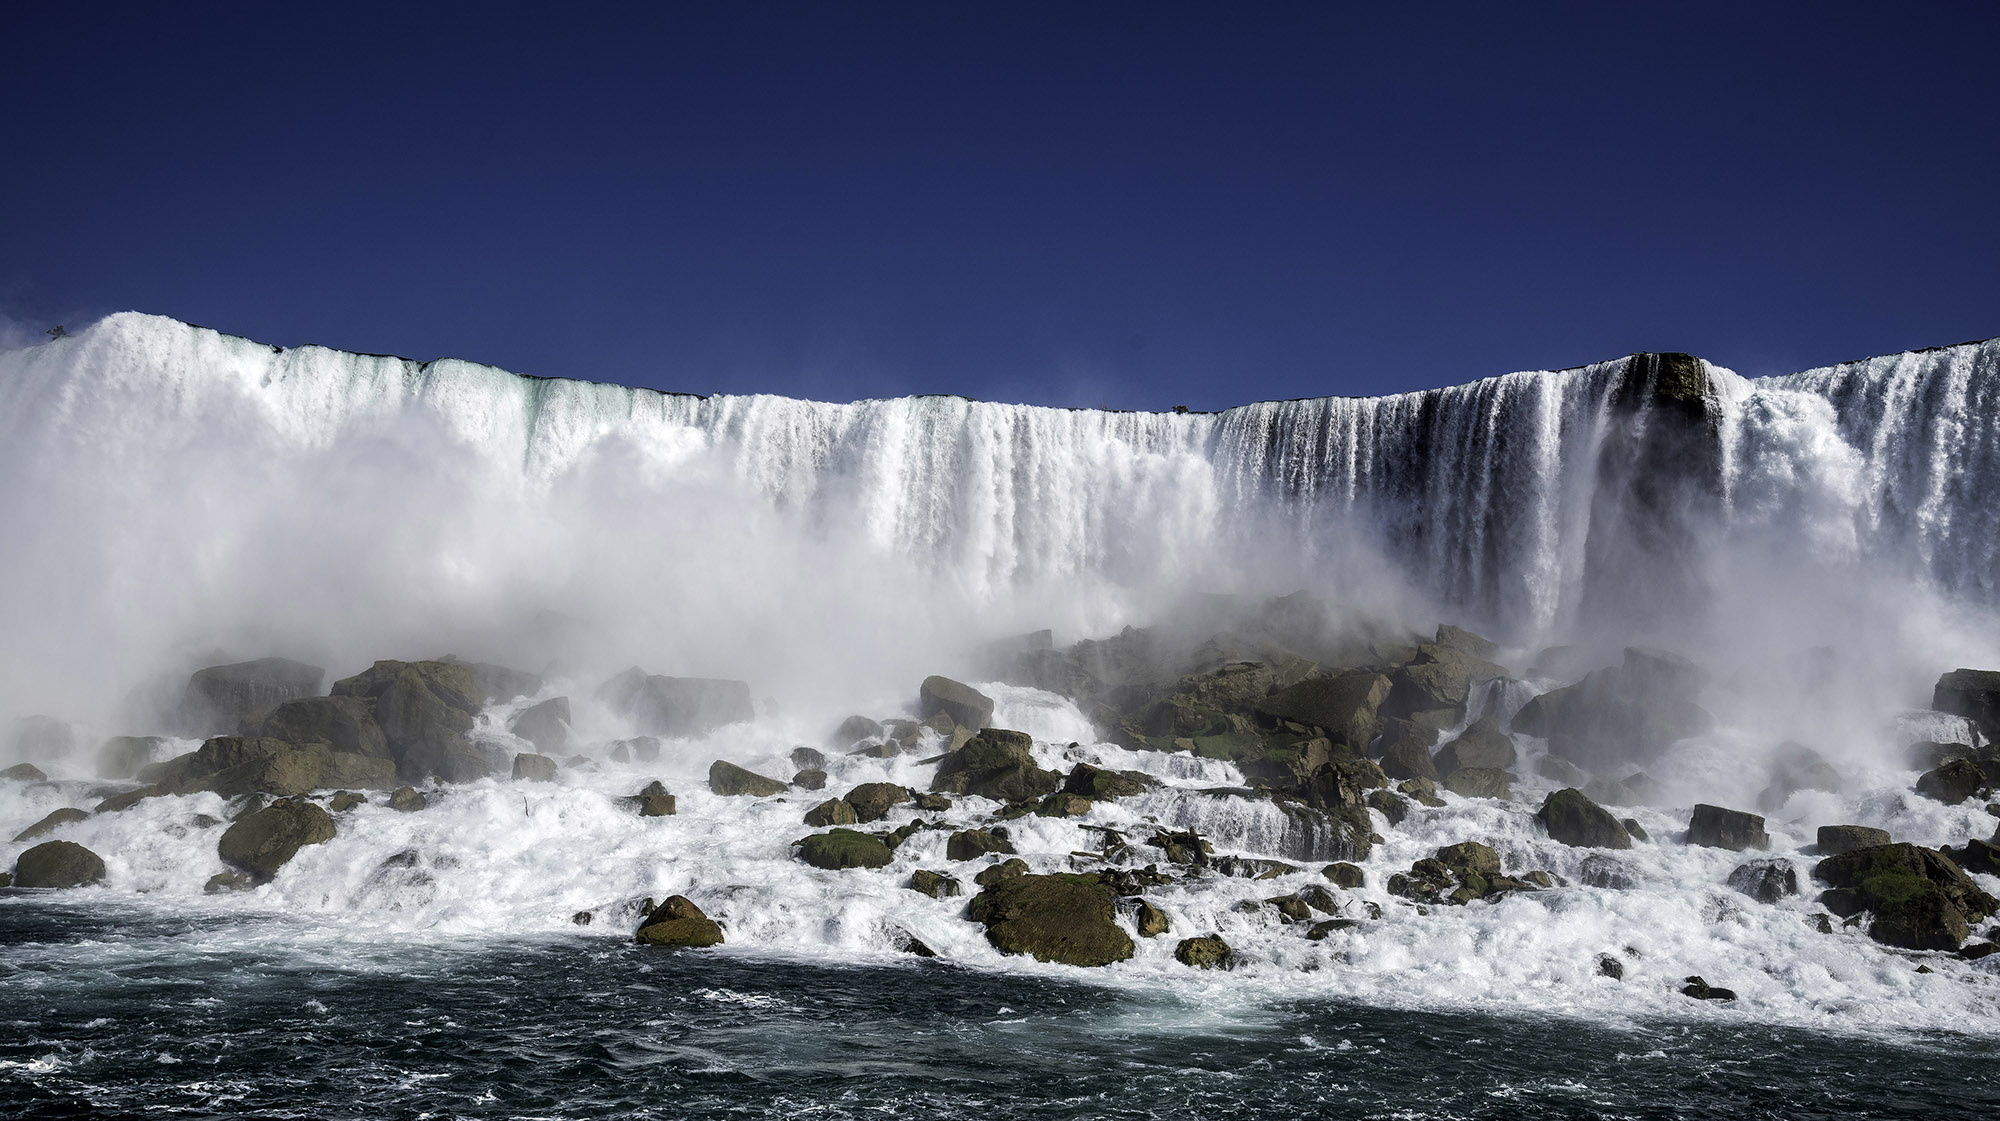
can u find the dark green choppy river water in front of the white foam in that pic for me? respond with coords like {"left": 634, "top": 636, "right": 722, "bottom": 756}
{"left": 0, "top": 893, "right": 2000, "bottom": 1119}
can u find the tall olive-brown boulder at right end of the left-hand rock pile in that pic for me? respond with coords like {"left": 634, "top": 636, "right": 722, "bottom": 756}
{"left": 332, "top": 661, "right": 494, "bottom": 783}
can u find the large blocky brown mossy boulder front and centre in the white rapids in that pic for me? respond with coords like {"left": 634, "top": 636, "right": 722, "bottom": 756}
{"left": 968, "top": 873, "right": 1134, "bottom": 965}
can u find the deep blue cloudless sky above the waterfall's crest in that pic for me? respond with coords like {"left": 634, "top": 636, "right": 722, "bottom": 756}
{"left": 0, "top": 2, "right": 2000, "bottom": 408}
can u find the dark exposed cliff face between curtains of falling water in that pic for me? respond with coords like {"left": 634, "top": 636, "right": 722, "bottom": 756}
{"left": 1582, "top": 354, "right": 1722, "bottom": 631}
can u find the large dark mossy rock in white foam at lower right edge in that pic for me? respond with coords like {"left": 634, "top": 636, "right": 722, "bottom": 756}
{"left": 1812, "top": 845, "right": 2000, "bottom": 949}
